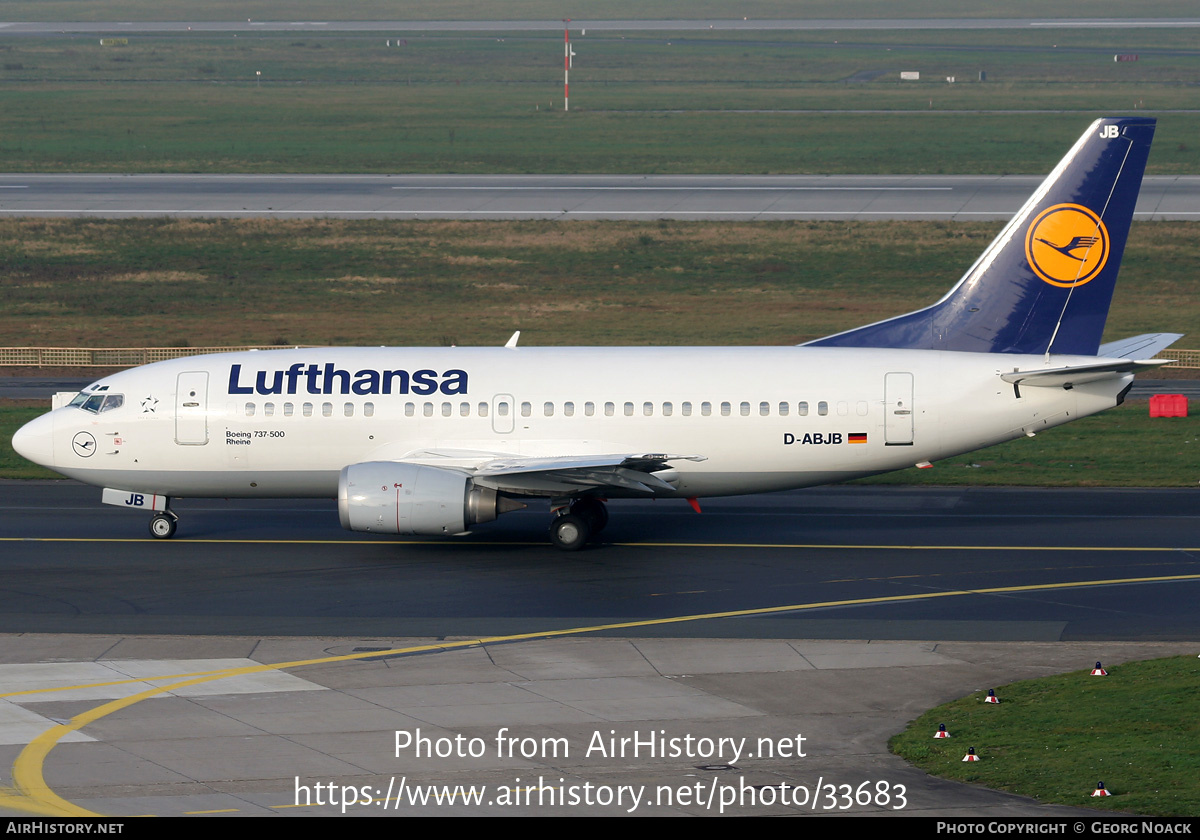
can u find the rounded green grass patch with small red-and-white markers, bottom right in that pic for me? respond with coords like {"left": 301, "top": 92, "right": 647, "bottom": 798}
{"left": 890, "top": 655, "right": 1200, "bottom": 816}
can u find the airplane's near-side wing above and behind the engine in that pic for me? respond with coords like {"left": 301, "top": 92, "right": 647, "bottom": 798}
{"left": 403, "top": 450, "right": 707, "bottom": 496}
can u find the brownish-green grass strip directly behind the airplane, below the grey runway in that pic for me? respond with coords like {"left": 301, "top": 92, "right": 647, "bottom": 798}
{"left": 0, "top": 218, "right": 1200, "bottom": 347}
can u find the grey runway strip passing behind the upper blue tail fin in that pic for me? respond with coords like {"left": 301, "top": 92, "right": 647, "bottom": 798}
{"left": 7, "top": 174, "right": 1200, "bottom": 221}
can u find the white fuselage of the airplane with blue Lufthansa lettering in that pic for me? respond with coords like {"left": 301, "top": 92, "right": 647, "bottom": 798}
{"left": 19, "top": 347, "right": 1132, "bottom": 498}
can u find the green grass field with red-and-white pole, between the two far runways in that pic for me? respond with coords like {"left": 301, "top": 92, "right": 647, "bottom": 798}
{"left": 0, "top": 30, "right": 1200, "bottom": 174}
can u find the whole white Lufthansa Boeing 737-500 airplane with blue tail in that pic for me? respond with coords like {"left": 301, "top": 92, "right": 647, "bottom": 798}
{"left": 13, "top": 118, "right": 1180, "bottom": 550}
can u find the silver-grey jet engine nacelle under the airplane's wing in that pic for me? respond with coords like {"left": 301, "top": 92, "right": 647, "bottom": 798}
{"left": 337, "top": 461, "right": 506, "bottom": 536}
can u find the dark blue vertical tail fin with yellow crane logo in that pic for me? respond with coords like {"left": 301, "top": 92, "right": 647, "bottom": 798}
{"left": 809, "top": 116, "right": 1154, "bottom": 355}
